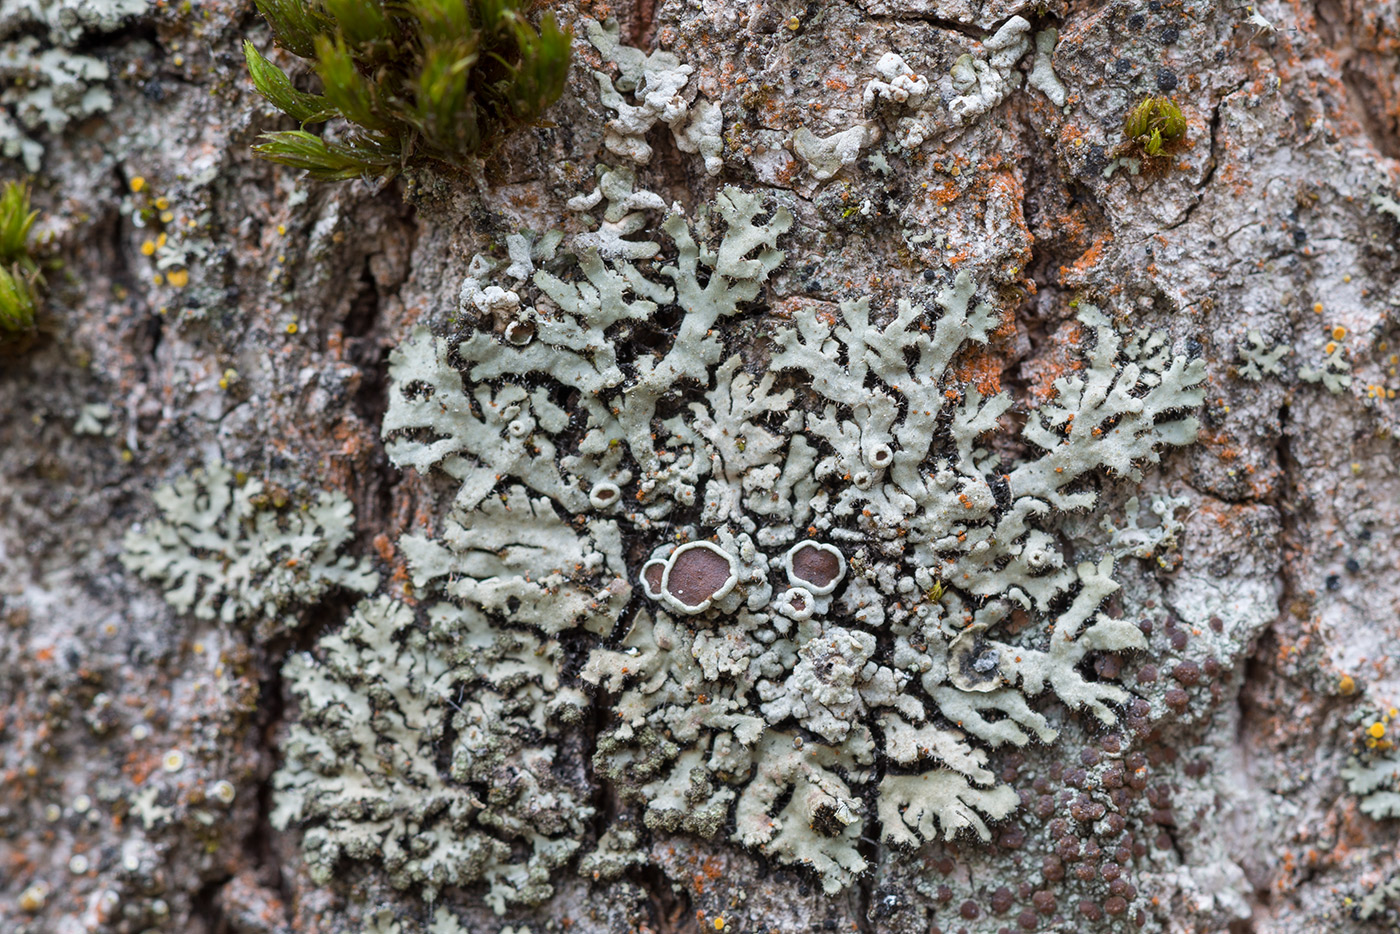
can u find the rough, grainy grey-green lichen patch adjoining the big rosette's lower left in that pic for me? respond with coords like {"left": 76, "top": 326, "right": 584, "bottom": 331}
{"left": 273, "top": 597, "right": 592, "bottom": 912}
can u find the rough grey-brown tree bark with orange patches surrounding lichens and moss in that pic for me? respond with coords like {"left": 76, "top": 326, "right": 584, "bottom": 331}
{"left": 0, "top": 0, "right": 1400, "bottom": 934}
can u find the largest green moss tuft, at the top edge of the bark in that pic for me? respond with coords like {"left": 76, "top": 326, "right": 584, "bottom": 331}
{"left": 244, "top": 0, "right": 571, "bottom": 179}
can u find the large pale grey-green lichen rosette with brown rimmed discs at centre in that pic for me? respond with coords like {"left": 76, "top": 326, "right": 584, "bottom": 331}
{"left": 384, "top": 182, "right": 1203, "bottom": 891}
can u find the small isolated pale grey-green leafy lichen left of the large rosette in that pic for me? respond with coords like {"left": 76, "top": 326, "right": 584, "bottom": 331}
{"left": 122, "top": 462, "right": 379, "bottom": 633}
